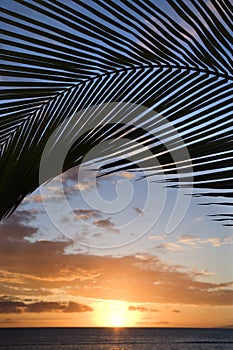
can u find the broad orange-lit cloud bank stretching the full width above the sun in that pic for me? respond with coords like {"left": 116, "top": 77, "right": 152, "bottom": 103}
{"left": 0, "top": 219, "right": 233, "bottom": 306}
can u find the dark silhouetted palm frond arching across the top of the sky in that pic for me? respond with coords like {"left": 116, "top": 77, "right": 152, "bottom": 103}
{"left": 0, "top": 0, "right": 233, "bottom": 225}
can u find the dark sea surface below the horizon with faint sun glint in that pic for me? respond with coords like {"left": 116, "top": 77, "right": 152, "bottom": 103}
{"left": 0, "top": 328, "right": 233, "bottom": 350}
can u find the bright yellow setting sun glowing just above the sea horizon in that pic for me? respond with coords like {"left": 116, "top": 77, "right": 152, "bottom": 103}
{"left": 95, "top": 300, "right": 136, "bottom": 328}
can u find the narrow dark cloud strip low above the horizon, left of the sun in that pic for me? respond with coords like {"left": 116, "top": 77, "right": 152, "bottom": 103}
{"left": 0, "top": 298, "right": 93, "bottom": 314}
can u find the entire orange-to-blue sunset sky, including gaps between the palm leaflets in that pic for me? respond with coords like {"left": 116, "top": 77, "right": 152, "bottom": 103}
{"left": 0, "top": 0, "right": 233, "bottom": 327}
